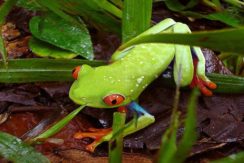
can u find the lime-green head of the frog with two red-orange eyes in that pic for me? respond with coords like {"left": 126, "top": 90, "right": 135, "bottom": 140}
{"left": 69, "top": 65, "right": 130, "bottom": 108}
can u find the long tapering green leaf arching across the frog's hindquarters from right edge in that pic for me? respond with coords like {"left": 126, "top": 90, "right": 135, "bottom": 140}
{"left": 119, "top": 27, "right": 244, "bottom": 55}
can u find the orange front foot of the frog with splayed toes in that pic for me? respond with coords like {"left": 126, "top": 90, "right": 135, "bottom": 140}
{"left": 74, "top": 128, "right": 112, "bottom": 152}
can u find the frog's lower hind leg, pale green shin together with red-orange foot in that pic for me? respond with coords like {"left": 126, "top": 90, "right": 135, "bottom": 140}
{"left": 190, "top": 47, "right": 217, "bottom": 96}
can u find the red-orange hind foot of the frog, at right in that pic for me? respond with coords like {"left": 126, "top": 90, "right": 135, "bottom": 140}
{"left": 190, "top": 58, "right": 217, "bottom": 96}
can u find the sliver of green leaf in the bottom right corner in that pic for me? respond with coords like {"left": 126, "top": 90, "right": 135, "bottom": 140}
{"left": 210, "top": 152, "right": 244, "bottom": 163}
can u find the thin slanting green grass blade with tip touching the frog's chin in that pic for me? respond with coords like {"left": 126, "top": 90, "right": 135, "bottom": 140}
{"left": 30, "top": 105, "right": 85, "bottom": 142}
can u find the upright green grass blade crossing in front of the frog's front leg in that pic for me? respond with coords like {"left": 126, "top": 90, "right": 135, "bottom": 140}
{"left": 109, "top": 112, "right": 126, "bottom": 163}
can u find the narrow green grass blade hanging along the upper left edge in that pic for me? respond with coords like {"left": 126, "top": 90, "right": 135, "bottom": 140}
{"left": 0, "top": 0, "right": 17, "bottom": 65}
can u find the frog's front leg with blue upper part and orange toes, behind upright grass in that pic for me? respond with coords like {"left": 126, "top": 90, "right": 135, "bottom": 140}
{"left": 74, "top": 102, "right": 155, "bottom": 152}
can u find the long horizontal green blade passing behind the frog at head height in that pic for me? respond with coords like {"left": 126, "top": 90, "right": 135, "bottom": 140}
{"left": 0, "top": 59, "right": 244, "bottom": 93}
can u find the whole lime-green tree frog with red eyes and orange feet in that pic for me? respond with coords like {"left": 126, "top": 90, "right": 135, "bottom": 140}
{"left": 69, "top": 19, "right": 216, "bottom": 151}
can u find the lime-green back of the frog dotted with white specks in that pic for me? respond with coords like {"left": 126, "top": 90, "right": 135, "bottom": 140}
{"left": 95, "top": 43, "right": 175, "bottom": 99}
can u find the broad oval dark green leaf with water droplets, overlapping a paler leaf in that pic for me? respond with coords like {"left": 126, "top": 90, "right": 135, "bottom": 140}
{"left": 30, "top": 13, "right": 94, "bottom": 60}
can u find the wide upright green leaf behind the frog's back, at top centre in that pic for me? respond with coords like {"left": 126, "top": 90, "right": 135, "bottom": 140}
{"left": 122, "top": 0, "right": 152, "bottom": 42}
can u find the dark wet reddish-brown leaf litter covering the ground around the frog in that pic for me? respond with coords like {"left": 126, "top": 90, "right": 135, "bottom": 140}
{"left": 0, "top": 2, "right": 244, "bottom": 162}
